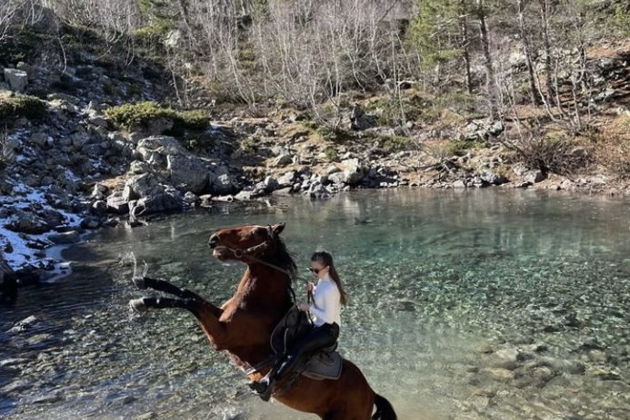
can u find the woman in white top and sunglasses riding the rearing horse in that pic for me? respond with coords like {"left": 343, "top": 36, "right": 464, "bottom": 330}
{"left": 250, "top": 251, "right": 346, "bottom": 401}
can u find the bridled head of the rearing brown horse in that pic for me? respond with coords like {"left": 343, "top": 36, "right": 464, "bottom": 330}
{"left": 208, "top": 223, "right": 284, "bottom": 261}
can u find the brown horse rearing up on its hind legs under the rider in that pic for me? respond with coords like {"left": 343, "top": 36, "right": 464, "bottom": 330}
{"left": 130, "top": 224, "right": 397, "bottom": 420}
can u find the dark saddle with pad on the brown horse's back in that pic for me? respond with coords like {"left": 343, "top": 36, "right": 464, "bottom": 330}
{"left": 270, "top": 306, "right": 343, "bottom": 380}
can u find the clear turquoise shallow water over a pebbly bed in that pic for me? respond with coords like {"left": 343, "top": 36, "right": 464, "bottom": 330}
{"left": 0, "top": 190, "right": 630, "bottom": 420}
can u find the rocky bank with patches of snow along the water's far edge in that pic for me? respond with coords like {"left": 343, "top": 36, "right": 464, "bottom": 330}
{"left": 0, "top": 26, "right": 630, "bottom": 298}
